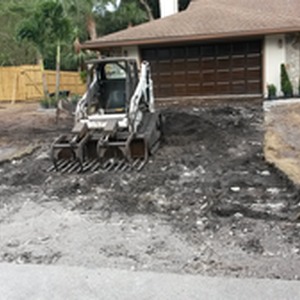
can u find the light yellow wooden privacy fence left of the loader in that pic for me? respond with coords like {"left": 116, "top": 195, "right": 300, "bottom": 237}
{"left": 0, "top": 65, "right": 86, "bottom": 101}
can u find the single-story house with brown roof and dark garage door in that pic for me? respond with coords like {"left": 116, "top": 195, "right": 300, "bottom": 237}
{"left": 83, "top": 0, "right": 300, "bottom": 97}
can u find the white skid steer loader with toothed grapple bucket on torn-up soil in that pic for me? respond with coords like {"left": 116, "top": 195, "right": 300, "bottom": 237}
{"left": 51, "top": 57, "right": 163, "bottom": 173}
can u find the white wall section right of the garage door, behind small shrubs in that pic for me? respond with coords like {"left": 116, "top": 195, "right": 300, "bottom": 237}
{"left": 264, "top": 34, "right": 286, "bottom": 97}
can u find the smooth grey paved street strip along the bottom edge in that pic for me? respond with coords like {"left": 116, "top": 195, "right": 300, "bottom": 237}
{"left": 0, "top": 264, "right": 300, "bottom": 300}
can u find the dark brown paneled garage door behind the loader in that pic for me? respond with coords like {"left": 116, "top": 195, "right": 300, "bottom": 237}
{"left": 142, "top": 40, "right": 262, "bottom": 97}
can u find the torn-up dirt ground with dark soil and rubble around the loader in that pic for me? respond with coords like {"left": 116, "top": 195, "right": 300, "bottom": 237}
{"left": 0, "top": 103, "right": 300, "bottom": 279}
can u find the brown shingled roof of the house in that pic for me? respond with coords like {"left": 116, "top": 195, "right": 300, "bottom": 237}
{"left": 83, "top": 0, "right": 300, "bottom": 49}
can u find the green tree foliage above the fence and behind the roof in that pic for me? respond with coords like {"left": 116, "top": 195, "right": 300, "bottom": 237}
{"left": 0, "top": 0, "right": 190, "bottom": 69}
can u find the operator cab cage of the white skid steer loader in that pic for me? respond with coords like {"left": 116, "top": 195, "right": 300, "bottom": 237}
{"left": 87, "top": 57, "right": 139, "bottom": 114}
